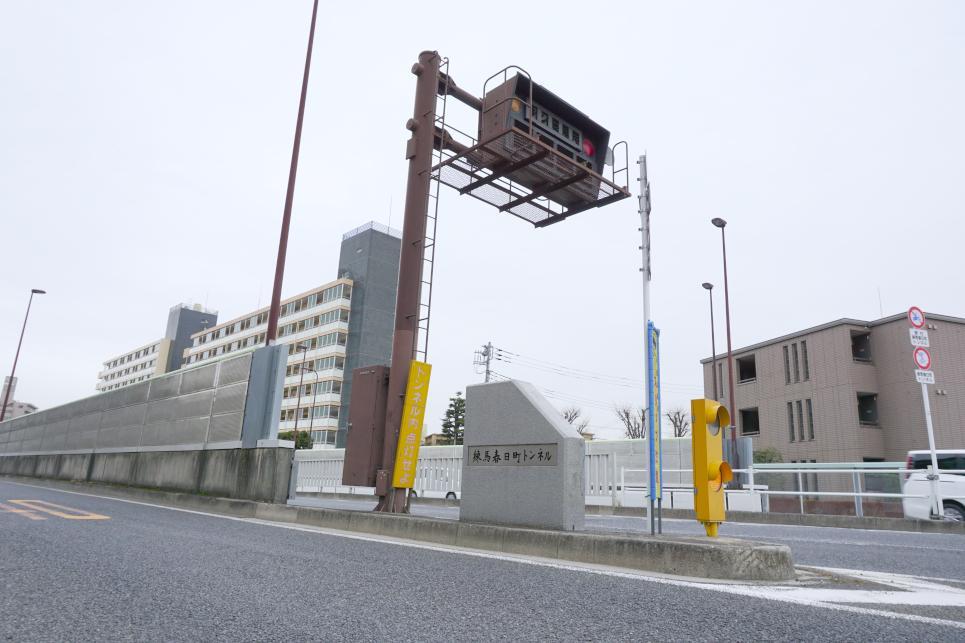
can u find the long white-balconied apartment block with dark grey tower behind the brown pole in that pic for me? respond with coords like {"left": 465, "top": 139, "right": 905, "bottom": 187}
{"left": 182, "top": 222, "right": 402, "bottom": 447}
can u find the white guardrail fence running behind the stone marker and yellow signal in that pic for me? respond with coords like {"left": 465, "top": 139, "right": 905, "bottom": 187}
{"left": 295, "top": 446, "right": 965, "bottom": 516}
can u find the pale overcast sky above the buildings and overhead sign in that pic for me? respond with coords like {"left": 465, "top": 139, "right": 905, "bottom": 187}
{"left": 0, "top": 0, "right": 965, "bottom": 437}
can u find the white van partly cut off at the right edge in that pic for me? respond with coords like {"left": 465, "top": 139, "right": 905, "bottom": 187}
{"left": 901, "top": 449, "right": 965, "bottom": 522}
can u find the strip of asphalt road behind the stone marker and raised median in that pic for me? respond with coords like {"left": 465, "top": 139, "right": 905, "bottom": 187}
{"left": 297, "top": 498, "right": 965, "bottom": 581}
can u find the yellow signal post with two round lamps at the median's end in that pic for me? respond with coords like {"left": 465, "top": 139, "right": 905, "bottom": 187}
{"left": 690, "top": 399, "right": 734, "bottom": 538}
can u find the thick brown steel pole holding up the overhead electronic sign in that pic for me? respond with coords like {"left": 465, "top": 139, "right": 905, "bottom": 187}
{"left": 375, "top": 51, "right": 440, "bottom": 513}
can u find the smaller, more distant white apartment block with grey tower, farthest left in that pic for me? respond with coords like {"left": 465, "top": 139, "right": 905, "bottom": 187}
{"left": 96, "top": 304, "right": 218, "bottom": 393}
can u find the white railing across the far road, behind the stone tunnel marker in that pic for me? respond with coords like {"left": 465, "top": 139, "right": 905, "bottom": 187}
{"left": 295, "top": 446, "right": 965, "bottom": 517}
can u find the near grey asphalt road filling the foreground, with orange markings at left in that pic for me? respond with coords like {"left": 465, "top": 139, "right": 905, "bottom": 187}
{"left": 0, "top": 481, "right": 965, "bottom": 641}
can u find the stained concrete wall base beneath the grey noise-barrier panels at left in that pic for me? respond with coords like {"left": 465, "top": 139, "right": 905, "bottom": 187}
{"left": 0, "top": 448, "right": 292, "bottom": 502}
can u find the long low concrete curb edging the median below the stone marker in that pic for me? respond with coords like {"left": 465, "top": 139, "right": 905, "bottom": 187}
{"left": 2, "top": 476, "right": 795, "bottom": 581}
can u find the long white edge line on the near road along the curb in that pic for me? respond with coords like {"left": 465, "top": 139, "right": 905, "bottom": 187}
{"left": 3, "top": 480, "right": 965, "bottom": 630}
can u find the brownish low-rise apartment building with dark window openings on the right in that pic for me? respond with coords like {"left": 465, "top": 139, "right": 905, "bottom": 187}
{"left": 701, "top": 313, "right": 965, "bottom": 462}
